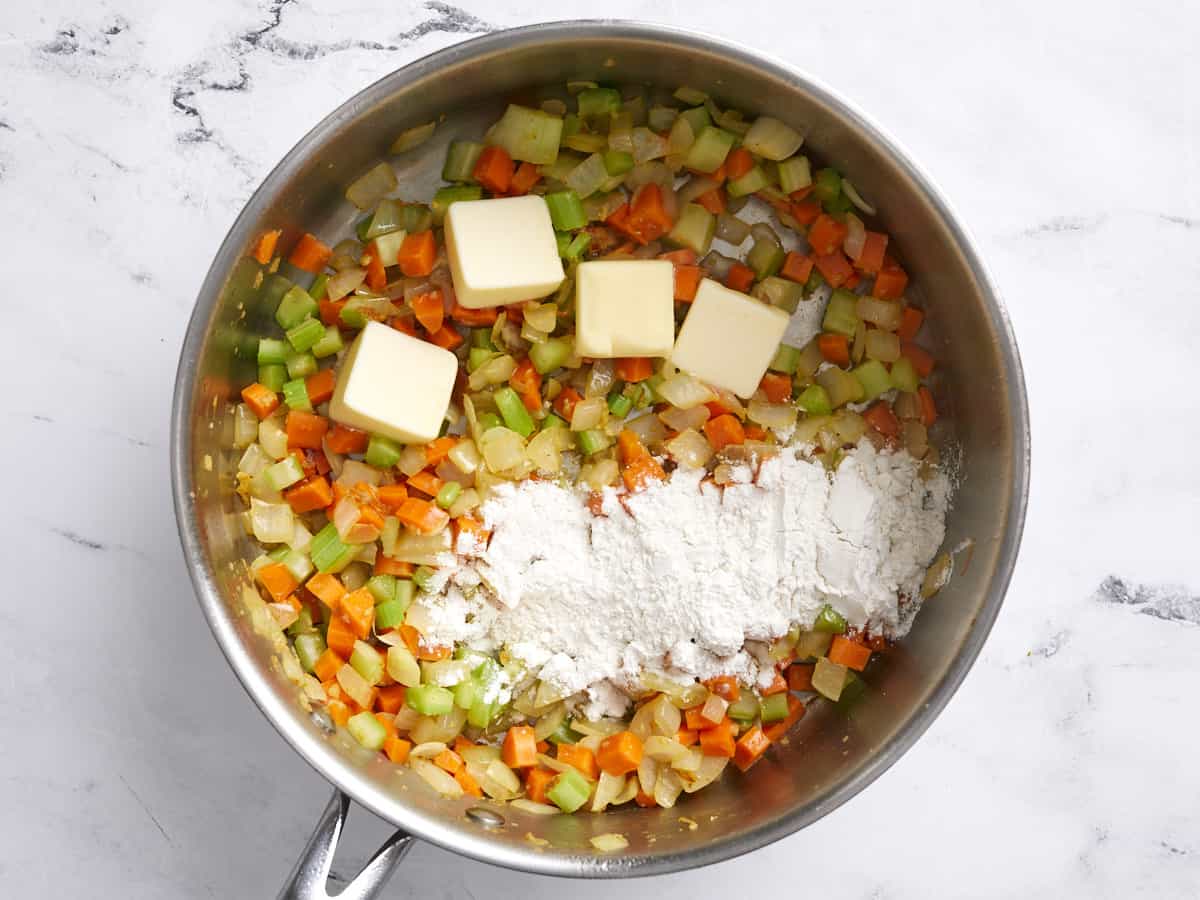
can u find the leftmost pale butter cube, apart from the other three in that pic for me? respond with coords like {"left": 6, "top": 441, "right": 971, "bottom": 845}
{"left": 329, "top": 322, "right": 458, "bottom": 444}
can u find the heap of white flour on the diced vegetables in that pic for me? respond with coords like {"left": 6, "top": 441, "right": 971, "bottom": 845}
{"left": 410, "top": 440, "right": 950, "bottom": 716}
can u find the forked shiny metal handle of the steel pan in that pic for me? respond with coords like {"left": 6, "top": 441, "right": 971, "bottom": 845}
{"left": 278, "top": 790, "right": 413, "bottom": 900}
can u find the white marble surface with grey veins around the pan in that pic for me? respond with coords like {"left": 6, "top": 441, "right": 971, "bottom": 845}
{"left": 0, "top": 0, "right": 1200, "bottom": 900}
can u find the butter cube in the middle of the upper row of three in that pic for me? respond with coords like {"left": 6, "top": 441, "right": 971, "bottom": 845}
{"left": 575, "top": 259, "right": 674, "bottom": 359}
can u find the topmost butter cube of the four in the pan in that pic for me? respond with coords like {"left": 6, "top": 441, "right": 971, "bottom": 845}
{"left": 445, "top": 194, "right": 563, "bottom": 310}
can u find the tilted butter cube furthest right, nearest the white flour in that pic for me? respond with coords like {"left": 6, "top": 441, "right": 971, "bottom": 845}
{"left": 671, "top": 278, "right": 788, "bottom": 397}
